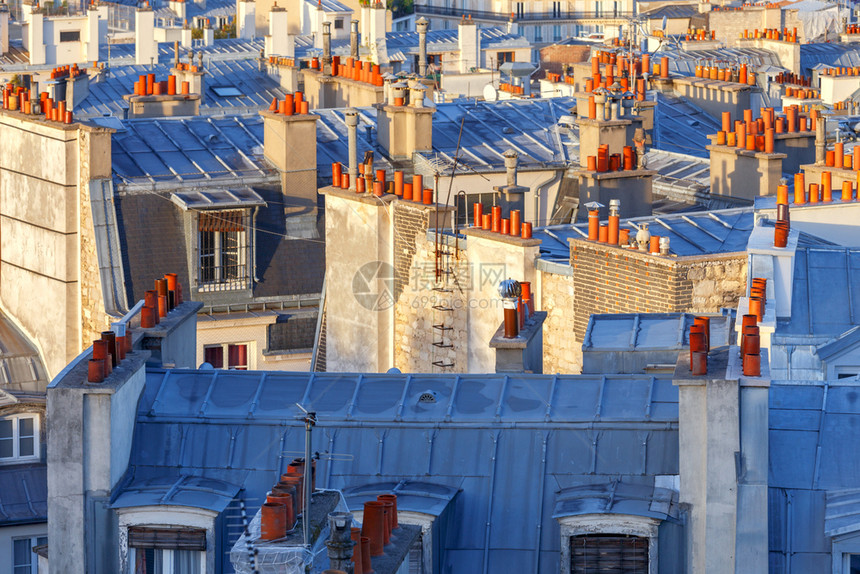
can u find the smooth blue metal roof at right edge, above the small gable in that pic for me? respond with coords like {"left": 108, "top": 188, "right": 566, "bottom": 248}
{"left": 777, "top": 247, "right": 860, "bottom": 336}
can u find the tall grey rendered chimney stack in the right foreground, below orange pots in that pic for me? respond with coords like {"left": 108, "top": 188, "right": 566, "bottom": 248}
{"left": 673, "top": 346, "right": 770, "bottom": 574}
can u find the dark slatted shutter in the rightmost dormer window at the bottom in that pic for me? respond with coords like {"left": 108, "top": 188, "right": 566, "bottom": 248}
{"left": 570, "top": 534, "right": 648, "bottom": 574}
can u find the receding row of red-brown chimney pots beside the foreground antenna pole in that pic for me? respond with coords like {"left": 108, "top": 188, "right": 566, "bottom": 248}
{"left": 260, "top": 458, "right": 317, "bottom": 541}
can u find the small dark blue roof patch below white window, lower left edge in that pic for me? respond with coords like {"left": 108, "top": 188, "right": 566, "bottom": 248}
{"left": 0, "top": 464, "right": 48, "bottom": 526}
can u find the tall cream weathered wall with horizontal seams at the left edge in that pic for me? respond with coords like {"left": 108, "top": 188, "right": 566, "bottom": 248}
{"left": 0, "top": 112, "right": 110, "bottom": 375}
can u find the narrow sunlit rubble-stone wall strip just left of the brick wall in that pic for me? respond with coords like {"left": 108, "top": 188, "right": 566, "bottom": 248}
{"left": 538, "top": 271, "right": 582, "bottom": 374}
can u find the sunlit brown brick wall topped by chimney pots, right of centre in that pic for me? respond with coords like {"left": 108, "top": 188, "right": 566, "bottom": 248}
{"left": 570, "top": 240, "right": 746, "bottom": 341}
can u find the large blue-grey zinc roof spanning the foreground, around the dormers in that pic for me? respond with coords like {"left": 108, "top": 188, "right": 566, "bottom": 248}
{"left": 129, "top": 370, "right": 678, "bottom": 574}
